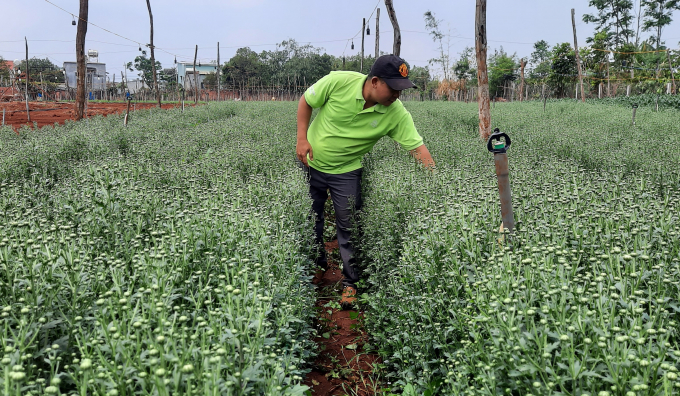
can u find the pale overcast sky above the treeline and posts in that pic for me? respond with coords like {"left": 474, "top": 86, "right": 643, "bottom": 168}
{"left": 0, "top": 0, "right": 680, "bottom": 81}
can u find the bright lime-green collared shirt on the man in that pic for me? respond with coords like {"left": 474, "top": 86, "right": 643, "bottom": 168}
{"left": 305, "top": 71, "right": 423, "bottom": 174}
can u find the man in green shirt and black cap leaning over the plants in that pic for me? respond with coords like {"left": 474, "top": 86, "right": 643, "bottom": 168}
{"left": 296, "top": 55, "right": 434, "bottom": 309}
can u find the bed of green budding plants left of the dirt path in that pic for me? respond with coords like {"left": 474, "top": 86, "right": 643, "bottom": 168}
{"left": 0, "top": 103, "right": 314, "bottom": 395}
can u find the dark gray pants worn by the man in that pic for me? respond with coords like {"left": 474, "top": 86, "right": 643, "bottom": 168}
{"left": 304, "top": 167, "right": 362, "bottom": 288}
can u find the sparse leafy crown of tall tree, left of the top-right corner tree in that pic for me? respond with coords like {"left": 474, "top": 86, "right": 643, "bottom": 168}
{"left": 583, "top": 0, "right": 634, "bottom": 48}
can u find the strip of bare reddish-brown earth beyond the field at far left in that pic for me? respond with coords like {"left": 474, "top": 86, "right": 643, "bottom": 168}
{"left": 0, "top": 102, "right": 177, "bottom": 130}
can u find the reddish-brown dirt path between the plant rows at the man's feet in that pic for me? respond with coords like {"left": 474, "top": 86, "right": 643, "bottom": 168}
{"left": 304, "top": 240, "right": 380, "bottom": 396}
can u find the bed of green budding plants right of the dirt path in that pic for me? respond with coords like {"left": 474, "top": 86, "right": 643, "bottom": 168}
{"left": 361, "top": 101, "right": 680, "bottom": 395}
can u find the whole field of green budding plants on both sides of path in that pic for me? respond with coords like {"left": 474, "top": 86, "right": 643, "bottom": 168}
{"left": 0, "top": 101, "right": 680, "bottom": 396}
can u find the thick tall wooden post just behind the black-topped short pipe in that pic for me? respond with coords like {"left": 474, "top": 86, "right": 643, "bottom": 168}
{"left": 475, "top": 0, "right": 491, "bottom": 142}
